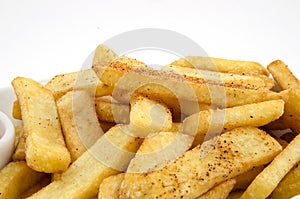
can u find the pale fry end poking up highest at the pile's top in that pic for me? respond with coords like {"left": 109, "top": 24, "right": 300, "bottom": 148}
{"left": 92, "top": 44, "right": 118, "bottom": 65}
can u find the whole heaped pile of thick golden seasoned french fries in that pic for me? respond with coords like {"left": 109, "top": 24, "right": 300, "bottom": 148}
{"left": 0, "top": 45, "right": 300, "bottom": 199}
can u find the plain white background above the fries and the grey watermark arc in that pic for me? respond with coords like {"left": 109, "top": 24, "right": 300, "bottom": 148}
{"left": 0, "top": 0, "right": 300, "bottom": 87}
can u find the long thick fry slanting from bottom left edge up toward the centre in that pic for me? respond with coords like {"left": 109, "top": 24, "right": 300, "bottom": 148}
{"left": 29, "top": 125, "right": 142, "bottom": 199}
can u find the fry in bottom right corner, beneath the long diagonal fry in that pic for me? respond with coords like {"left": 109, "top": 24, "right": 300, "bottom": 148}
{"left": 270, "top": 163, "right": 300, "bottom": 199}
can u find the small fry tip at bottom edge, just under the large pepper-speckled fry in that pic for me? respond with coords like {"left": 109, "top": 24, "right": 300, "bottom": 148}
{"left": 196, "top": 179, "right": 236, "bottom": 199}
